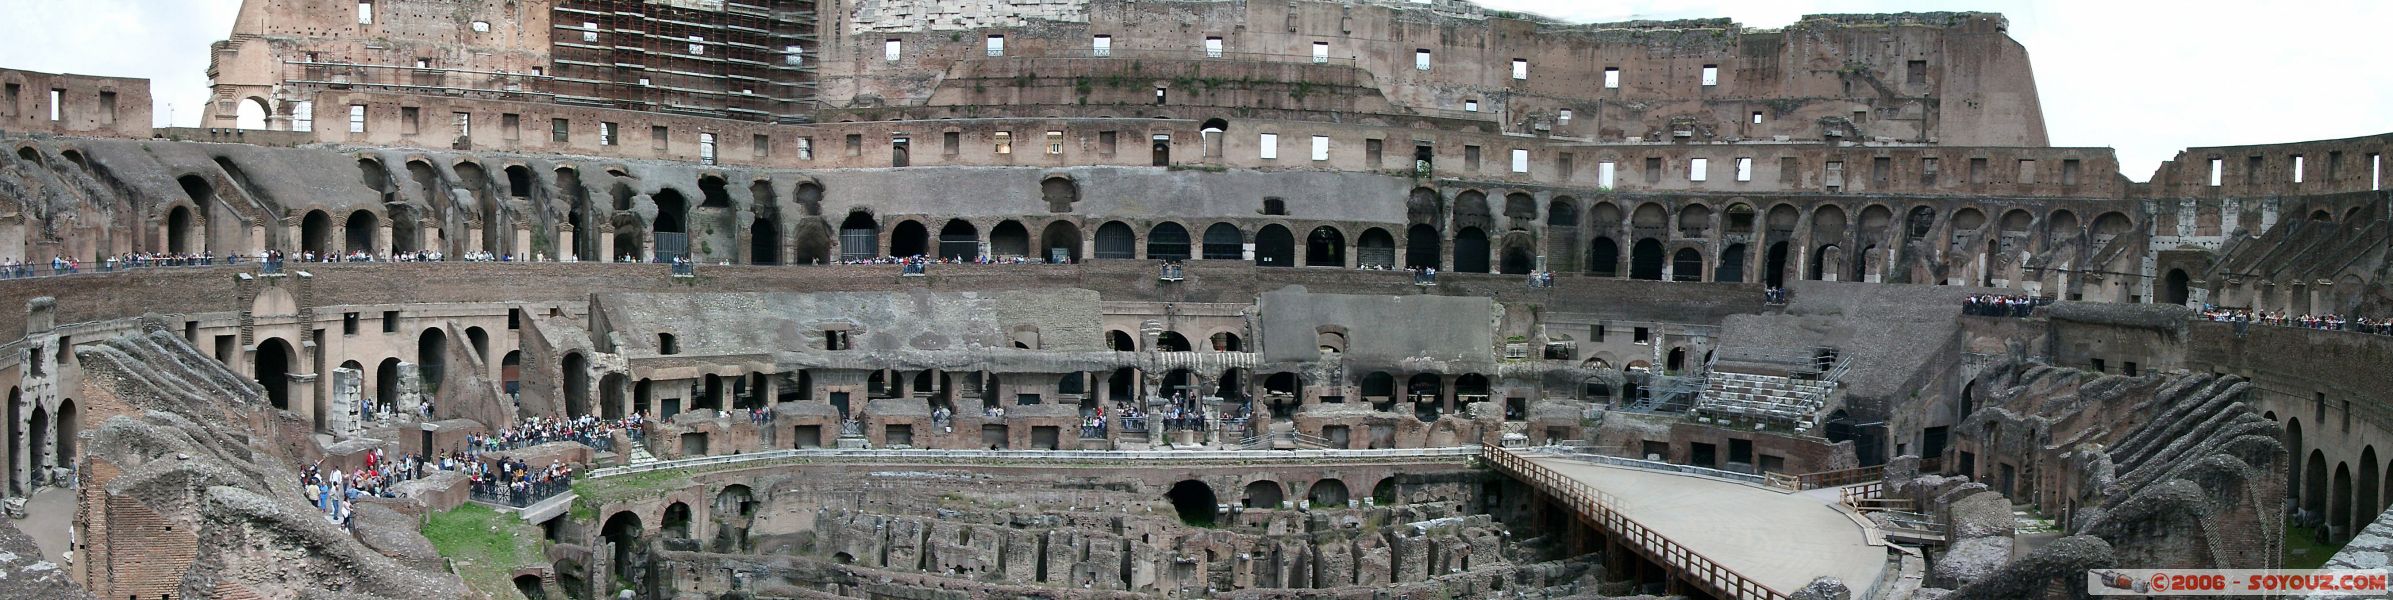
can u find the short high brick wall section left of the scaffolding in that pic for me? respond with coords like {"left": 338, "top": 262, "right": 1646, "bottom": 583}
{"left": 201, "top": 0, "right": 550, "bottom": 129}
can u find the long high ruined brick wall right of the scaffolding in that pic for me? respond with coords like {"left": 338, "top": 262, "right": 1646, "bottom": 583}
{"left": 821, "top": 0, "right": 2048, "bottom": 146}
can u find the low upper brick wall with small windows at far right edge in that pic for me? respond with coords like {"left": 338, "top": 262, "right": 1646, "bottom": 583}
{"left": 2130, "top": 134, "right": 2393, "bottom": 198}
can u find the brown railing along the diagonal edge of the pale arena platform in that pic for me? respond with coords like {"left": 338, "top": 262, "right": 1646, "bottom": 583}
{"left": 1479, "top": 445, "right": 1788, "bottom": 600}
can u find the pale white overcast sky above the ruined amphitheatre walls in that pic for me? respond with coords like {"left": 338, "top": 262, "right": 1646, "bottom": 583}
{"left": 0, "top": 0, "right": 2393, "bottom": 182}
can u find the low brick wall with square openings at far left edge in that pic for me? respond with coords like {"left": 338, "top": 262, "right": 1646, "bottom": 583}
{"left": 0, "top": 69, "right": 151, "bottom": 139}
